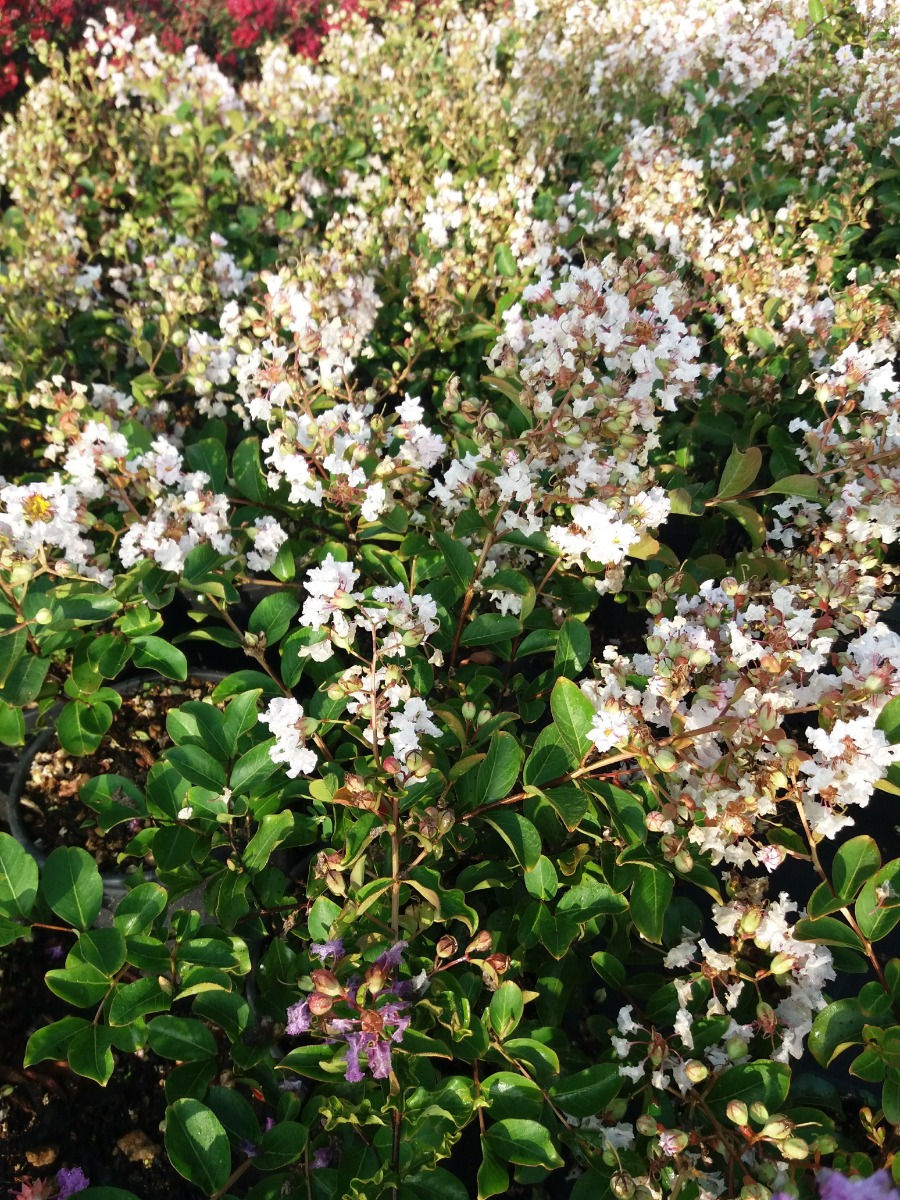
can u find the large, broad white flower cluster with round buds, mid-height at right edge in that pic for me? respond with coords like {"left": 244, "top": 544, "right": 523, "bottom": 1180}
{"left": 582, "top": 580, "right": 900, "bottom": 866}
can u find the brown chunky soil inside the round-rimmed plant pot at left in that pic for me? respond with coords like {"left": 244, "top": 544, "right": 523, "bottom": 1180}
{"left": 19, "top": 677, "right": 215, "bottom": 871}
